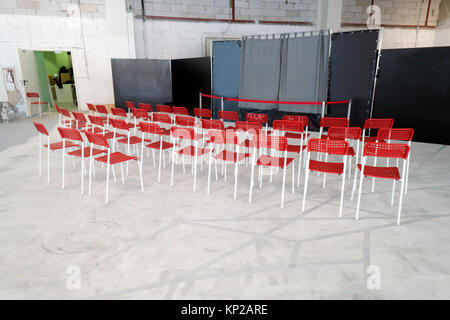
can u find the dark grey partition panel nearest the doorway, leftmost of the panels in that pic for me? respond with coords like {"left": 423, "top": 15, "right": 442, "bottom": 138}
{"left": 111, "top": 59, "right": 172, "bottom": 107}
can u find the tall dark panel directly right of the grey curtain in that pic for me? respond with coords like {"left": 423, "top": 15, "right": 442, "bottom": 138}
{"left": 327, "top": 30, "right": 379, "bottom": 127}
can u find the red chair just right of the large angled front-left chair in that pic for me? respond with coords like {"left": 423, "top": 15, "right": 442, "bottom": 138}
{"left": 139, "top": 122, "right": 173, "bottom": 183}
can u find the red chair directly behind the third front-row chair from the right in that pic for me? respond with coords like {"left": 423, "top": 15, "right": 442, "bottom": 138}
{"left": 272, "top": 120, "right": 306, "bottom": 192}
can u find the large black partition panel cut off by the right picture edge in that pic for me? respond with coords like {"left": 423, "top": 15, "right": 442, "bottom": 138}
{"left": 374, "top": 47, "right": 450, "bottom": 145}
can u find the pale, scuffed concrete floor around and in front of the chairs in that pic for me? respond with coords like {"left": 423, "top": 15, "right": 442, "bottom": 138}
{"left": 0, "top": 113, "right": 450, "bottom": 299}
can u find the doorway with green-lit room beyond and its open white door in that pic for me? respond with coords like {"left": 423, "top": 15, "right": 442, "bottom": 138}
{"left": 19, "top": 49, "right": 78, "bottom": 116}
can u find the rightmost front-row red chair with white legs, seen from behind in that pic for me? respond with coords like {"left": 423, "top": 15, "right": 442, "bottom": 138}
{"left": 352, "top": 142, "right": 409, "bottom": 225}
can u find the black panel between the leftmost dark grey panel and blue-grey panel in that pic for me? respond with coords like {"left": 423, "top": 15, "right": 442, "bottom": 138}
{"left": 172, "top": 57, "right": 211, "bottom": 110}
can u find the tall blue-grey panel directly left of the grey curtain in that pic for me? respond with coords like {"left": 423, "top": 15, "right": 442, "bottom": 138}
{"left": 212, "top": 40, "right": 241, "bottom": 118}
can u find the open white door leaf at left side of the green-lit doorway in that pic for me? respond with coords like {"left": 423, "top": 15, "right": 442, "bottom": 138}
{"left": 19, "top": 49, "right": 40, "bottom": 117}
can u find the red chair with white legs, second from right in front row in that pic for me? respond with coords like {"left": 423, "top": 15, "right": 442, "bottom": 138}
{"left": 302, "top": 139, "right": 348, "bottom": 218}
